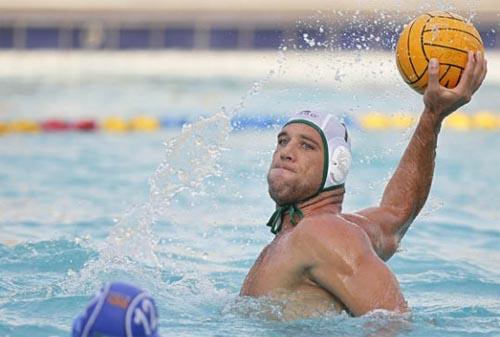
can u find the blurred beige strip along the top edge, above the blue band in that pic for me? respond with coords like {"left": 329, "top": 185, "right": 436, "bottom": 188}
{"left": 0, "top": 0, "right": 500, "bottom": 21}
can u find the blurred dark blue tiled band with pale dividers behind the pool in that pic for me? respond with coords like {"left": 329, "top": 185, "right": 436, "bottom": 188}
{"left": 0, "top": 22, "right": 498, "bottom": 50}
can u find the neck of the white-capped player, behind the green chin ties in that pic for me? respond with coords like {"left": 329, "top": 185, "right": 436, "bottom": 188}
{"left": 281, "top": 187, "right": 345, "bottom": 232}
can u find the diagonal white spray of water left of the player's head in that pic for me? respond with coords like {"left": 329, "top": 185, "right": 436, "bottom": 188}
{"left": 61, "top": 51, "right": 286, "bottom": 293}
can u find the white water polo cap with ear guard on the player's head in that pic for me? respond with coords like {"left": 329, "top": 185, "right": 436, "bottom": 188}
{"left": 285, "top": 110, "right": 352, "bottom": 193}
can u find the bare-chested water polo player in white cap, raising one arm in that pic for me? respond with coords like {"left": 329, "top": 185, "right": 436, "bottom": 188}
{"left": 240, "top": 52, "right": 486, "bottom": 318}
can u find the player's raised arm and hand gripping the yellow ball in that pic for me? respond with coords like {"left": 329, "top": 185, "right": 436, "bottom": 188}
{"left": 346, "top": 52, "right": 486, "bottom": 260}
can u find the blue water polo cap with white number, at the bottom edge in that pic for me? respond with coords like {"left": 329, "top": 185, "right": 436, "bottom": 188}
{"left": 72, "top": 282, "right": 159, "bottom": 337}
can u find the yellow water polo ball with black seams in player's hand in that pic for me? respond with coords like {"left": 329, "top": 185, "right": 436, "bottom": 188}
{"left": 396, "top": 11, "right": 484, "bottom": 94}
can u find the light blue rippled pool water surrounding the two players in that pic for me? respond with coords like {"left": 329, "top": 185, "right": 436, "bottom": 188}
{"left": 0, "top": 50, "right": 500, "bottom": 336}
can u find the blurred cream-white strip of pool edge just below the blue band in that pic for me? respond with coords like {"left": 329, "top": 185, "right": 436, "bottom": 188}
{"left": 0, "top": 50, "right": 500, "bottom": 87}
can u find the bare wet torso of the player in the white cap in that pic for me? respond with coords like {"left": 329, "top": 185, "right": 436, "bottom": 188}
{"left": 240, "top": 205, "right": 406, "bottom": 320}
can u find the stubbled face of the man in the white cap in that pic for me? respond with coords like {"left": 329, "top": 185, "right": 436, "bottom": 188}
{"left": 267, "top": 123, "right": 324, "bottom": 205}
